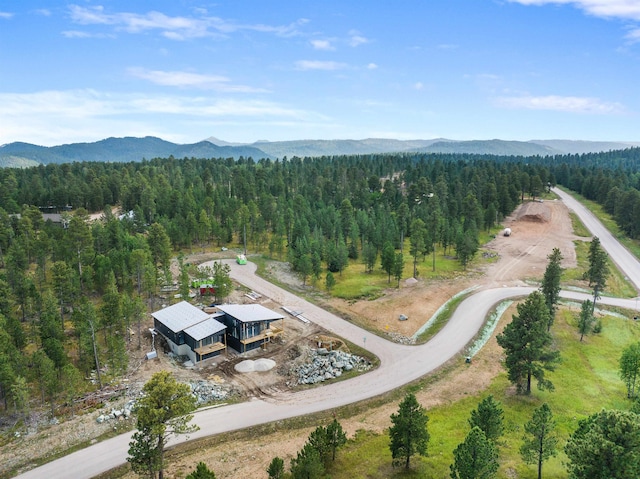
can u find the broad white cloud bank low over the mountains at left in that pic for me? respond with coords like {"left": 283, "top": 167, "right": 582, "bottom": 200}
{"left": 0, "top": 90, "right": 327, "bottom": 145}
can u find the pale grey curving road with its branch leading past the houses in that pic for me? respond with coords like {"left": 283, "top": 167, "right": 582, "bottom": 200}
{"left": 18, "top": 190, "right": 640, "bottom": 479}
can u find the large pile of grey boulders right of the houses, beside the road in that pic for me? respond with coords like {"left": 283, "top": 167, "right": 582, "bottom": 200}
{"left": 287, "top": 348, "right": 371, "bottom": 387}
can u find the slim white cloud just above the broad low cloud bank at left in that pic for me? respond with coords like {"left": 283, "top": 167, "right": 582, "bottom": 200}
{"left": 128, "top": 68, "right": 266, "bottom": 93}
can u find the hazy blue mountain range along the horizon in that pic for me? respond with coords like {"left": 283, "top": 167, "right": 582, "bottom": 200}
{"left": 0, "top": 136, "right": 640, "bottom": 167}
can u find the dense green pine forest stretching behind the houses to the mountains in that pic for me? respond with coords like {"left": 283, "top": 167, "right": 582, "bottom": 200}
{"left": 0, "top": 149, "right": 640, "bottom": 436}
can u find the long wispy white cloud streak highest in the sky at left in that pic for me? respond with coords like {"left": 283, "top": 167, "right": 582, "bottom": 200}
{"left": 69, "top": 5, "right": 308, "bottom": 40}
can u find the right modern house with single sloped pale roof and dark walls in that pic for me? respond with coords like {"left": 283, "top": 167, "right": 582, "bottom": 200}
{"left": 217, "top": 304, "right": 284, "bottom": 353}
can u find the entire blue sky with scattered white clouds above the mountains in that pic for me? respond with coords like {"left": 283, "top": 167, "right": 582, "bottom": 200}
{"left": 0, "top": 0, "right": 640, "bottom": 146}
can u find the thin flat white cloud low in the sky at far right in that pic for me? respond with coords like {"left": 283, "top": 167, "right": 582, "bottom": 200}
{"left": 497, "top": 95, "right": 624, "bottom": 115}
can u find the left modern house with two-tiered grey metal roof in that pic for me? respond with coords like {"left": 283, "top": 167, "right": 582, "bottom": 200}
{"left": 151, "top": 301, "right": 227, "bottom": 364}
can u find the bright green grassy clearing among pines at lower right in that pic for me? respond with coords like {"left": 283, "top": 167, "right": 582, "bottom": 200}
{"left": 324, "top": 308, "right": 640, "bottom": 479}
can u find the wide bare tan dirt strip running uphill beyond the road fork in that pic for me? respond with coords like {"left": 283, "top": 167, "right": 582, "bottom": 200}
{"left": 338, "top": 201, "right": 576, "bottom": 337}
